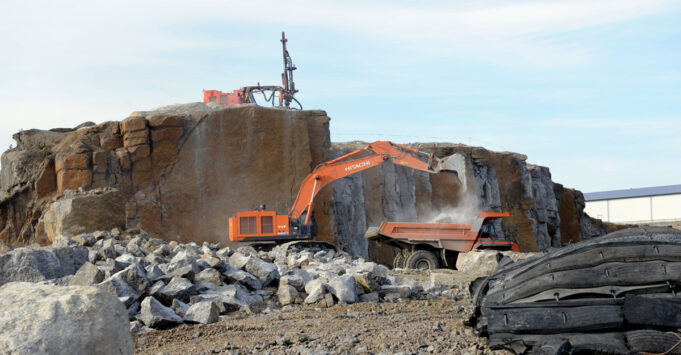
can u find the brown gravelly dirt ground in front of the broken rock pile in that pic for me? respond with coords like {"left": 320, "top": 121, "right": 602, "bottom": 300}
{"left": 135, "top": 272, "right": 510, "bottom": 355}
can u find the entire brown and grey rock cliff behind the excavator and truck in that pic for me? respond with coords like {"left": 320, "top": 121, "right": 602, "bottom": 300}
{"left": 0, "top": 103, "right": 605, "bottom": 256}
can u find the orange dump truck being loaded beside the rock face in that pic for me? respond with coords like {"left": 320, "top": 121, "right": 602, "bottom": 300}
{"left": 365, "top": 211, "right": 519, "bottom": 270}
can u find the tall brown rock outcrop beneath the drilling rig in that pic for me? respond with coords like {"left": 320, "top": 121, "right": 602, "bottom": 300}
{"left": 0, "top": 103, "right": 330, "bottom": 247}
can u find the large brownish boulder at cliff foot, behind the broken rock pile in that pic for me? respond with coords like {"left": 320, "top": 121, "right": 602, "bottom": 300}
{"left": 43, "top": 189, "right": 126, "bottom": 240}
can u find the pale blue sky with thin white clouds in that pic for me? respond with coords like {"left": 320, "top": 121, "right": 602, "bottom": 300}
{"left": 0, "top": 0, "right": 681, "bottom": 192}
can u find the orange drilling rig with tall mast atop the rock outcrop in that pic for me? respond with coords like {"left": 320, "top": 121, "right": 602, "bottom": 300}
{"left": 203, "top": 32, "right": 303, "bottom": 110}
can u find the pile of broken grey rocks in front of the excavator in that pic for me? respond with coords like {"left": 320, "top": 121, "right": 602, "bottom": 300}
{"left": 0, "top": 228, "right": 463, "bottom": 332}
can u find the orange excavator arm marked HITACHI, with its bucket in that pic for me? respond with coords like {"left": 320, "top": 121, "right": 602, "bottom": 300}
{"left": 289, "top": 141, "right": 465, "bottom": 225}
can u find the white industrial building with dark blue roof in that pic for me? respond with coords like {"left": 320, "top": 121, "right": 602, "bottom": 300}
{"left": 584, "top": 185, "right": 681, "bottom": 229}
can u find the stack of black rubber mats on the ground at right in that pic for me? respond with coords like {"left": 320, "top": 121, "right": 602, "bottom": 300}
{"left": 469, "top": 227, "right": 681, "bottom": 354}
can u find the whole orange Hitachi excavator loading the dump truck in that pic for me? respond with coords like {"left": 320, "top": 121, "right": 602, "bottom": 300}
{"left": 229, "top": 141, "right": 466, "bottom": 242}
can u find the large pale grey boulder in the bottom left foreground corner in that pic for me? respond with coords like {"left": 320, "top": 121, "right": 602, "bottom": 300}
{"left": 0, "top": 282, "right": 134, "bottom": 354}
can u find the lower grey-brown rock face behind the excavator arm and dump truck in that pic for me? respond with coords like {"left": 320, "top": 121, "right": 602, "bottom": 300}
{"left": 329, "top": 142, "right": 607, "bottom": 263}
